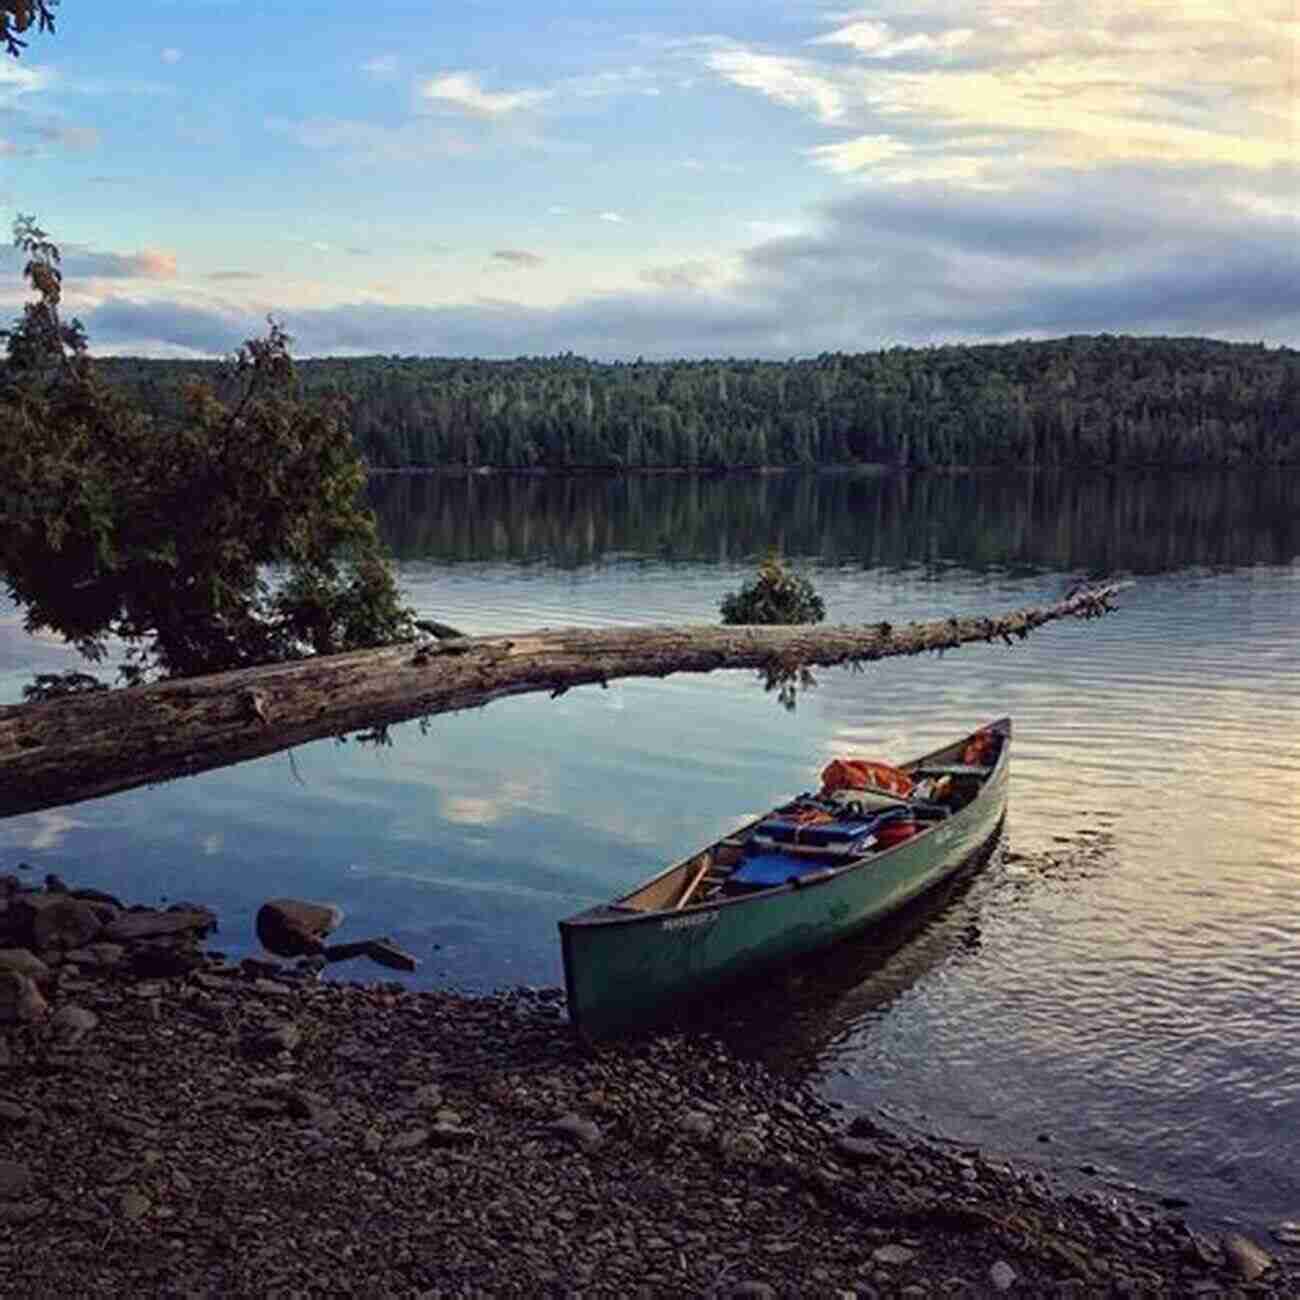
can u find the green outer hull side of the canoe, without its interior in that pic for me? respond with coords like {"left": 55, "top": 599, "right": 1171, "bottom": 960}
{"left": 560, "top": 719, "right": 1010, "bottom": 1039}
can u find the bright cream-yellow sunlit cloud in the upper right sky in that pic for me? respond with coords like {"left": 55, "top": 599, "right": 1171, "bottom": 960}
{"left": 703, "top": 0, "right": 1300, "bottom": 185}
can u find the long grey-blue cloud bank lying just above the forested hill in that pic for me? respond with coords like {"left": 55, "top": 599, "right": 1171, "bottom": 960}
{"left": 79, "top": 165, "right": 1300, "bottom": 359}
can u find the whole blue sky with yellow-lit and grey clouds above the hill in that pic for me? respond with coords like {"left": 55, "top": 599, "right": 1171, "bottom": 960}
{"left": 0, "top": 0, "right": 1300, "bottom": 359}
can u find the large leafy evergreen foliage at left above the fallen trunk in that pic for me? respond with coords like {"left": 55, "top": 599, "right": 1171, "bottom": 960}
{"left": 0, "top": 217, "right": 413, "bottom": 680}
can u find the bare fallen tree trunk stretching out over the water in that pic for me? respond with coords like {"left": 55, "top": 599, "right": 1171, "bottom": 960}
{"left": 0, "top": 584, "right": 1127, "bottom": 815}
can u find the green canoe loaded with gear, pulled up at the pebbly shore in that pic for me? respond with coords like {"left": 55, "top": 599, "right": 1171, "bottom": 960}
{"left": 560, "top": 718, "right": 1011, "bottom": 1039}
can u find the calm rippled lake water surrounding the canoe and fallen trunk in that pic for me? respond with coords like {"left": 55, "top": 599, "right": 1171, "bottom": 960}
{"left": 0, "top": 471, "right": 1300, "bottom": 1230}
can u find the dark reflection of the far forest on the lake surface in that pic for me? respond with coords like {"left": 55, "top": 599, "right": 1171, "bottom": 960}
{"left": 371, "top": 469, "right": 1300, "bottom": 573}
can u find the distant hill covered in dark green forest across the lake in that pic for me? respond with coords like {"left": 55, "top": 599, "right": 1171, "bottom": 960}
{"left": 101, "top": 334, "right": 1300, "bottom": 469}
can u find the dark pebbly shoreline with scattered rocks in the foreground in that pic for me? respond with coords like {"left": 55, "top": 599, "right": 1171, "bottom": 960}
{"left": 0, "top": 876, "right": 1300, "bottom": 1297}
